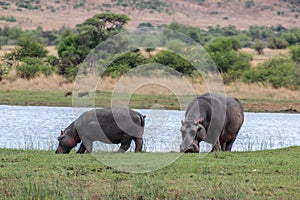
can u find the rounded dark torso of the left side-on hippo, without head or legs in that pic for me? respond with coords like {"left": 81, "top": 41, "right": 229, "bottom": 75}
{"left": 75, "top": 108, "right": 144, "bottom": 144}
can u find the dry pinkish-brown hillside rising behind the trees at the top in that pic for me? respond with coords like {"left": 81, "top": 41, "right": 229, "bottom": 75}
{"left": 0, "top": 0, "right": 300, "bottom": 30}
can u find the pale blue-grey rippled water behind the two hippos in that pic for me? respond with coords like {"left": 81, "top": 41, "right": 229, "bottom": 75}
{"left": 0, "top": 105, "right": 300, "bottom": 152}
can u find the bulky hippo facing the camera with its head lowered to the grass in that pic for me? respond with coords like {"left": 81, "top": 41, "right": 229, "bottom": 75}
{"left": 180, "top": 93, "right": 244, "bottom": 153}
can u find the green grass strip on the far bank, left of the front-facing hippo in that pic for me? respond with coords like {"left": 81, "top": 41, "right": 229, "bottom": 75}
{"left": 0, "top": 91, "right": 191, "bottom": 109}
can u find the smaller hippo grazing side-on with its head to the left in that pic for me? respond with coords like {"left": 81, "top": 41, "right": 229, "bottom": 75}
{"left": 56, "top": 108, "right": 145, "bottom": 153}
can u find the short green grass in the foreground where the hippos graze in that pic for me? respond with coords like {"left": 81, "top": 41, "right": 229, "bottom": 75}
{"left": 0, "top": 147, "right": 300, "bottom": 199}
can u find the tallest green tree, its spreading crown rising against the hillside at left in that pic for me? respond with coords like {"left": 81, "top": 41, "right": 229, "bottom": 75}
{"left": 58, "top": 12, "right": 130, "bottom": 77}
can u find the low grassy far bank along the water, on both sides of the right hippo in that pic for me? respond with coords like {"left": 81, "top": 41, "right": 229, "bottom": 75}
{"left": 0, "top": 91, "right": 300, "bottom": 112}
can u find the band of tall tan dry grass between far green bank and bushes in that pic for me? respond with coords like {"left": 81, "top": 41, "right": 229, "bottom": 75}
{"left": 0, "top": 75, "right": 300, "bottom": 101}
